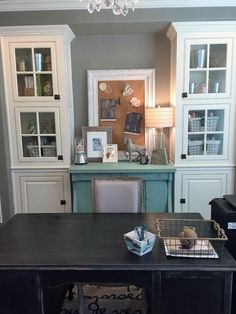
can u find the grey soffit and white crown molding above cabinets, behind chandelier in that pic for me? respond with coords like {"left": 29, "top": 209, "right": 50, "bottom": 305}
{"left": 0, "top": 0, "right": 236, "bottom": 34}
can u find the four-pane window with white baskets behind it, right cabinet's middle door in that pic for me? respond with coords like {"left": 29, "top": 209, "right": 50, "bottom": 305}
{"left": 184, "top": 105, "right": 228, "bottom": 159}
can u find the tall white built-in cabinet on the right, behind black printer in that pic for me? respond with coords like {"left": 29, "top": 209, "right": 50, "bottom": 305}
{"left": 167, "top": 22, "right": 236, "bottom": 218}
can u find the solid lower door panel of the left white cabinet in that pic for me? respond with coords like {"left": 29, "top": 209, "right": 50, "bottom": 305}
{"left": 20, "top": 176, "right": 65, "bottom": 213}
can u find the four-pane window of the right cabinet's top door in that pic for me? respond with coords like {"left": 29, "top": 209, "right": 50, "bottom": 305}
{"left": 185, "top": 40, "right": 232, "bottom": 98}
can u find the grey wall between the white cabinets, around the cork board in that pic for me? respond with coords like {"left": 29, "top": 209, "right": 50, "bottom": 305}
{"left": 72, "top": 33, "right": 170, "bottom": 135}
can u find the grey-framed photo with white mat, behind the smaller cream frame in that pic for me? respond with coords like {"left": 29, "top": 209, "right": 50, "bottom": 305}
{"left": 82, "top": 126, "right": 112, "bottom": 161}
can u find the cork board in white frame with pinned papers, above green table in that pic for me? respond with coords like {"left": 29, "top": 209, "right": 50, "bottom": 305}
{"left": 88, "top": 69, "right": 155, "bottom": 152}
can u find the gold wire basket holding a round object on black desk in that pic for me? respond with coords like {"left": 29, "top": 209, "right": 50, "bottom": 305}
{"left": 156, "top": 219, "right": 228, "bottom": 258}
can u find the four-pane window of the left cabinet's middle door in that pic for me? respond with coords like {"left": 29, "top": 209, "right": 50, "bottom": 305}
{"left": 15, "top": 108, "right": 61, "bottom": 161}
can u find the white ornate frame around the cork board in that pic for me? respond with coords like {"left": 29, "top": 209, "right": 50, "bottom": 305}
{"left": 87, "top": 69, "right": 155, "bottom": 154}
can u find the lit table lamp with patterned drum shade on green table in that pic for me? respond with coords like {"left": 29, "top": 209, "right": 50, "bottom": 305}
{"left": 145, "top": 107, "right": 173, "bottom": 165}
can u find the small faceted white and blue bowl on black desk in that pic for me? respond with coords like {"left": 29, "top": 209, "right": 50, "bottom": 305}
{"left": 124, "top": 230, "right": 156, "bottom": 256}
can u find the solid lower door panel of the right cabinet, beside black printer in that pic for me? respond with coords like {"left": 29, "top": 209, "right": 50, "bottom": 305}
{"left": 182, "top": 174, "right": 226, "bottom": 219}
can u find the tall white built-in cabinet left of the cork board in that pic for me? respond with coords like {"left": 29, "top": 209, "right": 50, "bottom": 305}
{"left": 0, "top": 25, "right": 74, "bottom": 213}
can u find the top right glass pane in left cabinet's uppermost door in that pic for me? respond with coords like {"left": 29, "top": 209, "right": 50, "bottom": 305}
{"left": 34, "top": 48, "right": 52, "bottom": 72}
